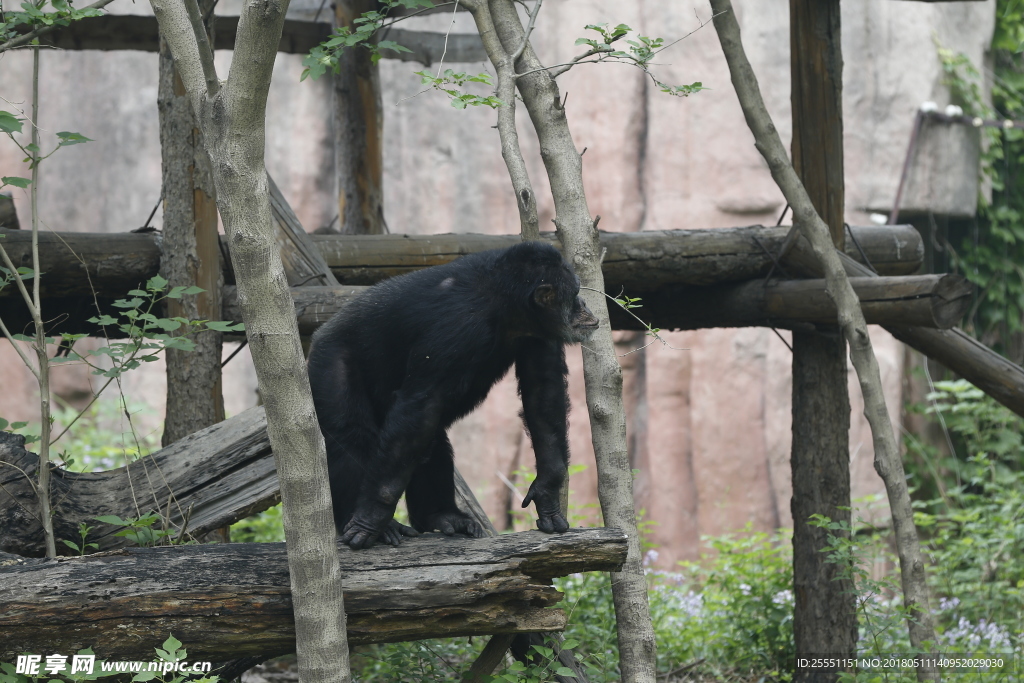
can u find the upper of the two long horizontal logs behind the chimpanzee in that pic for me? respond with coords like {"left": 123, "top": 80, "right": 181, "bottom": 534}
{"left": 0, "top": 225, "right": 924, "bottom": 301}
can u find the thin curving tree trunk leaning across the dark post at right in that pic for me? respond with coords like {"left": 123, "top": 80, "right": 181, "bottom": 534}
{"left": 712, "top": 0, "right": 938, "bottom": 680}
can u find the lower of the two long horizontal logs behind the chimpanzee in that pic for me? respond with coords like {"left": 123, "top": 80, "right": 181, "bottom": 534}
{"left": 224, "top": 275, "right": 972, "bottom": 336}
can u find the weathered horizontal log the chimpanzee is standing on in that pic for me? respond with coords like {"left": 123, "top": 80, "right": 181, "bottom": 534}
{"left": 0, "top": 528, "right": 626, "bottom": 660}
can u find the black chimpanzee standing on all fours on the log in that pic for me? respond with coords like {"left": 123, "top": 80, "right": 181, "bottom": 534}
{"left": 309, "top": 242, "right": 598, "bottom": 548}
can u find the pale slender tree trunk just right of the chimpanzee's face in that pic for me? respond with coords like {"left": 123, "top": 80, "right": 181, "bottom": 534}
{"left": 467, "top": 0, "right": 655, "bottom": 683}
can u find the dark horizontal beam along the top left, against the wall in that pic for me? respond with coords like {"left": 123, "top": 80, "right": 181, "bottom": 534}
{"left": 24, "top": 14, "right": 487, "bottom": 66}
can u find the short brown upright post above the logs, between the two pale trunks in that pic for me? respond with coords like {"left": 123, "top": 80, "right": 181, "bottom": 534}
{"left": 334, "top": 0, "right": 387, "bottom": 234}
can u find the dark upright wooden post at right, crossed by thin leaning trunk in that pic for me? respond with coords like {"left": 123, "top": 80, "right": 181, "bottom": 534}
{"left": 790, "top": 0, "right": 857, "bottom": 683}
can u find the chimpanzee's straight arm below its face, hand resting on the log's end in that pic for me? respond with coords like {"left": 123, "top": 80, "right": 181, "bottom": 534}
{"left": 515, "top": 337, "right": 569, "bottom": 533}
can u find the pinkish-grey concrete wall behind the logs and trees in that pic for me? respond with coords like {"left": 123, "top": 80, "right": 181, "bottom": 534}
{"left": 0, "top": 0, "right": 994, "bottom": 565}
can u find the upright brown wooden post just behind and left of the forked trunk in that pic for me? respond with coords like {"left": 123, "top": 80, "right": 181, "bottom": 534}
{"left": 158, "top": 1, "right": 224, "bottom": 445}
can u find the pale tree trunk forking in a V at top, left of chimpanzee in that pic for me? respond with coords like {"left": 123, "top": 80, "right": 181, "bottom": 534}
{"left": 152, "top": 0, "right": 351, "bottom": 683}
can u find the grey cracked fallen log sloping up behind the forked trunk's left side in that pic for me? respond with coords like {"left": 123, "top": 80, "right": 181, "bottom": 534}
{"left": 0, "top": 408, "right": 281, "bottom": 557}
